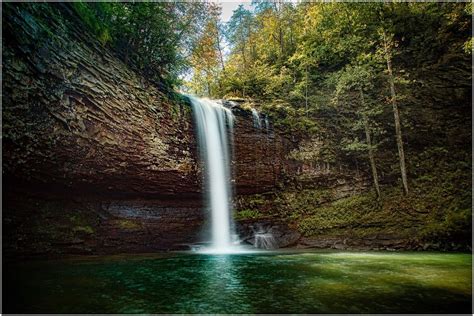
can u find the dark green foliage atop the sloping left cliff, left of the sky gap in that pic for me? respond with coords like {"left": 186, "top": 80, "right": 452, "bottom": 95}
{"left": 71, "top": 2, "right": 213, "bottom": 88}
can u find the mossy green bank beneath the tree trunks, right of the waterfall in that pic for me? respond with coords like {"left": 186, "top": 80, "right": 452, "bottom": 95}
{"left": 292, "top": 160, "right": 472, "bottom": 244}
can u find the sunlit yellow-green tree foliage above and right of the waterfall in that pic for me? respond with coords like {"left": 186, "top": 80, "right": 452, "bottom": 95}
{"left": 182, "top": 2, "right": 472, "bottom": 195}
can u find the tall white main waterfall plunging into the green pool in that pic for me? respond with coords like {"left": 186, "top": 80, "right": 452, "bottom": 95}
{"left": 189, "top": 96, "right": 234, "bottom": 252}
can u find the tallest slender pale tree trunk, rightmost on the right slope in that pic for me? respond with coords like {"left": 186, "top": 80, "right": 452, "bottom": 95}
{"left": 383, "top": 31, "right": 408, "bottom": 194}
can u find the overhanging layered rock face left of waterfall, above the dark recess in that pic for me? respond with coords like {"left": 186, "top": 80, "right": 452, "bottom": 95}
{"left": 3, "top": 5, "right": 200, "bottom": 195}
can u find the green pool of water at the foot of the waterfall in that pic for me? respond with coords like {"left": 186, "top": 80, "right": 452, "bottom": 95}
{"left": 3, "top": 252, "right": 471, "bottom": 313}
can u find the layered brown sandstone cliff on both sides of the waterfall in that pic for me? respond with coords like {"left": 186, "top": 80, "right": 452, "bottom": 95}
{"left": 3, "top": 4, "right": 289, "bottom": 254}
